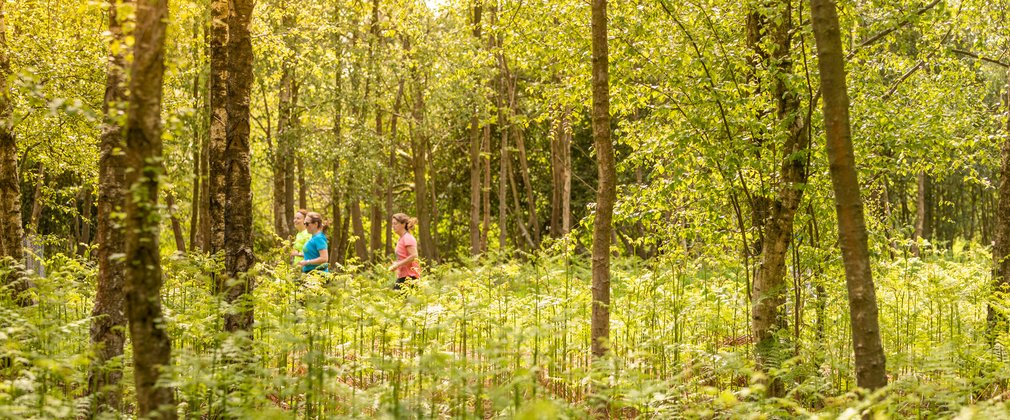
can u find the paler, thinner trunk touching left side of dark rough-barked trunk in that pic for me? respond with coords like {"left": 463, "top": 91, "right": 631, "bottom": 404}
{"left": 206, "top": 0, "right": 230, "bottom": 257}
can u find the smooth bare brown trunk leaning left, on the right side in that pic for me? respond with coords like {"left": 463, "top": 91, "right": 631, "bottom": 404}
{"left": 810, "top": 0, "right": 887, "bottom": 390}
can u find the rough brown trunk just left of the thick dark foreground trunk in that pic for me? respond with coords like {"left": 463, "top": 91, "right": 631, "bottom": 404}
{"left": 87, "top": 1, "right": 126, "bottom": 409}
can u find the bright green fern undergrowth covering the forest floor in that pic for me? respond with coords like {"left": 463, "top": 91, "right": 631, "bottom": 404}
{"left": 0, "top": 243, "right": 1010, "bottom": 418}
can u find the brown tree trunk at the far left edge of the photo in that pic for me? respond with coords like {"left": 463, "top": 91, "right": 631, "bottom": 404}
{"left": 0, "top": 0, "right": 26, "bottom": 305}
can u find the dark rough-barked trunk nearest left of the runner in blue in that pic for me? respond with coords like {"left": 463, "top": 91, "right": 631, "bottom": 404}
{"left": 224, "top": 0, "right": 258, "bottom": 332}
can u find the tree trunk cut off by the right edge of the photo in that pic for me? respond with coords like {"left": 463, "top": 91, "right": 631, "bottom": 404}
{"left": 982, "top": 46, "right": 1010, "bottom": 337}
